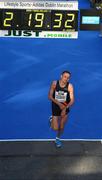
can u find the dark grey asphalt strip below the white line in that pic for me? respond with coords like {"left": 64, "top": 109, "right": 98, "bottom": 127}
{"left": 0, "top": 141, "right": 102, "bottom": 180}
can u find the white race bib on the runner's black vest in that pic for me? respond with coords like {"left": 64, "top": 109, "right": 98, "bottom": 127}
{"left": 55, "top": 91, "right": 67, "bottom": 102}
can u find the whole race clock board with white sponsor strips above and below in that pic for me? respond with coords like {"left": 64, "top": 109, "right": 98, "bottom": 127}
{"left": 0, "top": 0, "right": 78, "bottom": 38}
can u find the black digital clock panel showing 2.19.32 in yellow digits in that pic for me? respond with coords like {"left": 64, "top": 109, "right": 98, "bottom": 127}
{"left": 0, "top": 9, "right": 78, "bottom": 31}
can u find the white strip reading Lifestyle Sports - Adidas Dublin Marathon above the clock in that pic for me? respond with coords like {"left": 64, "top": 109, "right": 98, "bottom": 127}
{"left": 0, "top": 1, "right": 78, "bottom": 10}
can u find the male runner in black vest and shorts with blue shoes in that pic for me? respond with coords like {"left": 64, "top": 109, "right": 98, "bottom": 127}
{"left": 48, "top": 71, "right": 74, "bottom": 147}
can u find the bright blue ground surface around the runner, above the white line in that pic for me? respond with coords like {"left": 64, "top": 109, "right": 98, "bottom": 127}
{"left": 0, "top": 0, "right": 102, "bottom": 139}
